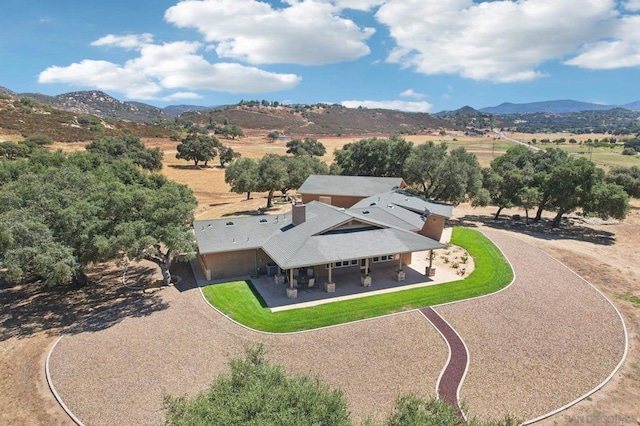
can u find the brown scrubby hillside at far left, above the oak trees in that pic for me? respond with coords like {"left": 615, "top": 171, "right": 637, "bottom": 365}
{"left": 0, "top": 91, "right": 174, "bottom": 142}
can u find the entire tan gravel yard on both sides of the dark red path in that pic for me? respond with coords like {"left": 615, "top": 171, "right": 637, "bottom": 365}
{"left": 50, "top": 232, "right": 625, "bottom": 425}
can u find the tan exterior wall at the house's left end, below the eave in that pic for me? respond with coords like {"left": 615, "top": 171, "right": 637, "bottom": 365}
{"left": 198, "top": 249, "right": 271, "bottom": 280}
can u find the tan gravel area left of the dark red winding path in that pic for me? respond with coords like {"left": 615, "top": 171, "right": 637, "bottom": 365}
{"left": 50, "top": 272, "right": 448, "bottom": 425}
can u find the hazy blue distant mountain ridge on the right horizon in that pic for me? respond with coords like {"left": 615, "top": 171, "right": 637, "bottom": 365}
{"left": 480, "top": 100, "right": 640, "bottom": 114}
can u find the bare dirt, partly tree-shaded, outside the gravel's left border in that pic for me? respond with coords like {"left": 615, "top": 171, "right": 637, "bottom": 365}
{"left": 0, "top": 265, "right": 164, "bottom": 425}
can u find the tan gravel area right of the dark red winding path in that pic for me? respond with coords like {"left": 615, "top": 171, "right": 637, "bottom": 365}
{"left": 436, "top": 232, "right": 625, "bottom": 419}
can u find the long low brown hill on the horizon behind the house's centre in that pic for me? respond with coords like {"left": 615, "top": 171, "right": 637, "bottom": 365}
{"left": 179, "top": 104, "right": 454, "bottom": 136}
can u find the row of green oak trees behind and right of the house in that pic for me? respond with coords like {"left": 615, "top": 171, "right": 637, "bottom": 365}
{"left": 316, "top": 136, "right": 640, "bottom": 227}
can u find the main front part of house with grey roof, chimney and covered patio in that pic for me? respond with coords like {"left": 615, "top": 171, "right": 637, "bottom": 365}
{"left": 193, "top": 194, "right": 446, "bottom": 291}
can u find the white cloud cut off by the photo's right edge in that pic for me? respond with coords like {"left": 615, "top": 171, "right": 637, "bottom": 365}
{"left": 565, "top": 15, "right": 640, "bottom": 70}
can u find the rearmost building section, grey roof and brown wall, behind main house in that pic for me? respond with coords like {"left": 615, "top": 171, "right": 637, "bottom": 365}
{"left": 297, "top": 175, "right": 407, "bottom": 209}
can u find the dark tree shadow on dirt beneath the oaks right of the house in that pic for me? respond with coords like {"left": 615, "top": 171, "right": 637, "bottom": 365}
{"left": 450, "top": 215, "right": 615, "bottom": 246}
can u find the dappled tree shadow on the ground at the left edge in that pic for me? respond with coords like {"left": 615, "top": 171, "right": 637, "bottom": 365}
{"left": 0, "top": 266, "right": 169, "bottom": 341}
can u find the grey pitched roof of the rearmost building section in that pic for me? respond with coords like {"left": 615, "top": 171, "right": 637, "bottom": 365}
{"left": 298, "top": 175, "right": 404, "bottom": 197}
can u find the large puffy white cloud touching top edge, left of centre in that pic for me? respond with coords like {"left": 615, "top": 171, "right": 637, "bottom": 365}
{"left": 165, "top": 0, "right": 378, "bottom": 65}
